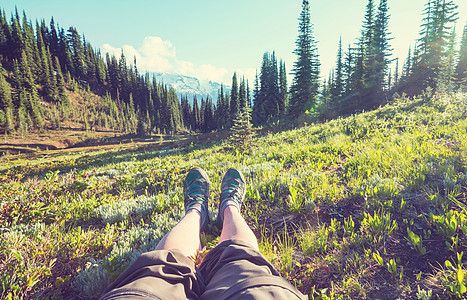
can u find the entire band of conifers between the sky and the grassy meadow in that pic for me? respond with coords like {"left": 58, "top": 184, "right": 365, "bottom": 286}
{"left": 0, "top": 0, "right": 467, "bottom": 134}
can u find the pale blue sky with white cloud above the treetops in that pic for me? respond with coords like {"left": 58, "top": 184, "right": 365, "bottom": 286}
{"left": 0, "top": 0, "right": 467, "bottom": 84}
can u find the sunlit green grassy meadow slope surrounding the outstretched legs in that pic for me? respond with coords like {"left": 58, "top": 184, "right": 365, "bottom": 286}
{"left": 0, "top": 94, "right": 467, "bottom": 299}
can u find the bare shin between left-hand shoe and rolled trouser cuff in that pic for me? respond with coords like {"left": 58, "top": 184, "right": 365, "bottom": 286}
{"left": 155, "top": 209, "right": 201, "bottom": 257}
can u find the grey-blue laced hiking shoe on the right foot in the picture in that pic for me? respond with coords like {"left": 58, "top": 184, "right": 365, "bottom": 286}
{"left": 216, "top": 168, "right": 246, "bottom": 229}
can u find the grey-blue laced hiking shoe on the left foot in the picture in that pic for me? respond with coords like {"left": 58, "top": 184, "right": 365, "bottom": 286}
{"left": 183, "top": 167, "right": 211, "bottom": 230}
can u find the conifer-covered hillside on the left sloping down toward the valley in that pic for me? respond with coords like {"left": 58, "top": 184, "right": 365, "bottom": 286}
{"left": 0, "top": 11, "right": 225, "bottom": 135}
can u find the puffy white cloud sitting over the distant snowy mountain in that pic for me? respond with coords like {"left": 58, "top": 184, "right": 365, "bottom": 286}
{"left": 101, "top": 36, "right": 230, "bottom": 83}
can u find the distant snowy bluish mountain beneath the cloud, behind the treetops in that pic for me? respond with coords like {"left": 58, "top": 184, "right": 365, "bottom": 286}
{"left": 152, "top": 73, "right": 230, "bottom": 103}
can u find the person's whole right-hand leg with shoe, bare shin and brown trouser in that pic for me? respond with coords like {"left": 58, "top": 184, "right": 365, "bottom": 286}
{"left": 200, "top": 169, "right": 307, "bottom": 300}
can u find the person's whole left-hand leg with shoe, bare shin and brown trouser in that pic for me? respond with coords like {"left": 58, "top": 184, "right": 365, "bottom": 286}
{"left": 101, "top": 168, "right": 214, "bottom": 300}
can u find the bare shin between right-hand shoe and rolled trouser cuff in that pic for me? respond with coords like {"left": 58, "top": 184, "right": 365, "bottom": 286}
{"left": 219, "top": 205, "right": 259, "bottom": 251}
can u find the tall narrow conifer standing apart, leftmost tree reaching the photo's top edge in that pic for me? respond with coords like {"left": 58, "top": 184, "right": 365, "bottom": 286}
{"left": 288, "top": 0, "right": 320, "bottom": 118}
